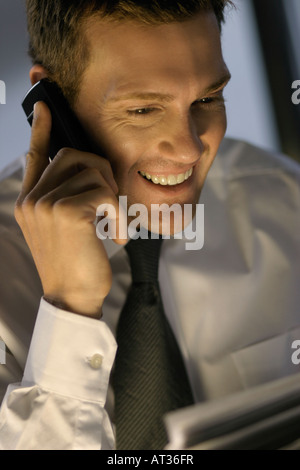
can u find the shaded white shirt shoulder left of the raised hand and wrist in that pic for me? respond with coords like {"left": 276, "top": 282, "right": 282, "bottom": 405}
{"left": 0, "top": 157, "right": 42, "bottom": 370}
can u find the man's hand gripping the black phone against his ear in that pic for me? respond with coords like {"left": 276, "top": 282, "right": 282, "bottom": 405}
{"left": 15, "top": 102, "right": 124, "bottom": 317}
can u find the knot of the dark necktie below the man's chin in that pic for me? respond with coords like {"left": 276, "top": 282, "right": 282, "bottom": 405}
{"left": 125, "top": 238, "right": 163, "bottom": 283}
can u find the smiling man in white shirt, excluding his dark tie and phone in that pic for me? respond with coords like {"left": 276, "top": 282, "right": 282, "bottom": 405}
{"left": 0, "top": 0, "right": 300, "bottom": 449}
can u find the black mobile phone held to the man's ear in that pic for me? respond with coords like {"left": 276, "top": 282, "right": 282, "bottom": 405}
{"left": 22, "top": 79, "right": 95, "bottom": 159}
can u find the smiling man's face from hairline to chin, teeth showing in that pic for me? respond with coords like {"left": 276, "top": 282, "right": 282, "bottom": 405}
{"left": 75, "top": 12, "right": 229, "bottom": 234}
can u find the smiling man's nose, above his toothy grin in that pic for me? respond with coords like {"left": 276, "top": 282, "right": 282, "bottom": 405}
{"left": 158, "top": 116, "right": 204, "bottom": 164}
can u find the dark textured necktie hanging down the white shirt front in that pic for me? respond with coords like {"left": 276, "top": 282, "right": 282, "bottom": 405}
{"left": 113, "top": 238, "right": 193, "bottom": 450}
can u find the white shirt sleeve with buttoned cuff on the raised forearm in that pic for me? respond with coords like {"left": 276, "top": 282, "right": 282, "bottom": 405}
{"left": 0, "top": 299, "right": 116, "bottom": 450}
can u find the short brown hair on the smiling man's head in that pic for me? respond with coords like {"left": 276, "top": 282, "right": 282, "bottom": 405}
{"left": 26, "top": 0, "right": 232, "bottom": 106}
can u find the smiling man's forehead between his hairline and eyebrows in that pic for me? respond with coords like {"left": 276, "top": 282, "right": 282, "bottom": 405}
{"left": 81, "top": 12, "right": 226, "bottom": 96}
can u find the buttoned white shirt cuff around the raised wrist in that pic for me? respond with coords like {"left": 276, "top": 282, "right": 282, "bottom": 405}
{"left": 22, "top": 299, "right": 117, "bottom": 406}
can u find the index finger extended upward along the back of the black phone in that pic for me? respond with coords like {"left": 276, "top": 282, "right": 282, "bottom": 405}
{"left": 21, "top": 101, "right": 51, "bottom": 198}
